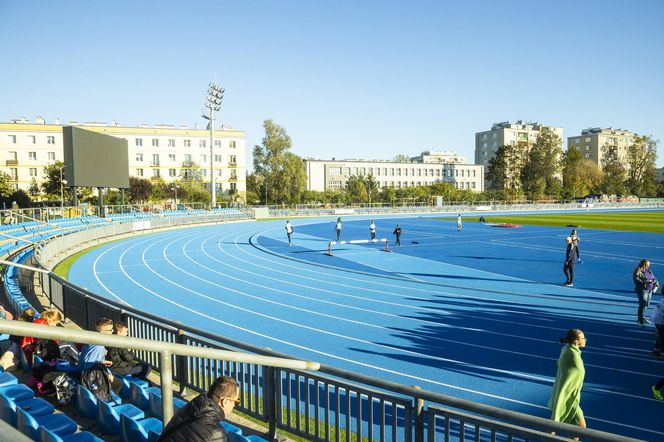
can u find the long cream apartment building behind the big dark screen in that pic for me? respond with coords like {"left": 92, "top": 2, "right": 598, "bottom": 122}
{"left": 0, "top": 117, "right": 247, "bottom": 198}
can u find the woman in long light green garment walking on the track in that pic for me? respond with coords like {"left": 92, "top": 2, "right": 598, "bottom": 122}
{"left": 549, "top": 328, "right": 587, "bottom": 428}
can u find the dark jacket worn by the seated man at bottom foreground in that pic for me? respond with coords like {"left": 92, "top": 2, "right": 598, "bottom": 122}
{"left": 159, "top": 394, "right": 228, "bottom": 442}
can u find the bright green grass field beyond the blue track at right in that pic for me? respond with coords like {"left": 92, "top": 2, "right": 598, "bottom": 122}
{"left": 436, "top": 211, "right": 664, "bottom": 233}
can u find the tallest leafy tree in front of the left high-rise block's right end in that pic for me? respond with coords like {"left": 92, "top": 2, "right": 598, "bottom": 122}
{"left": 521, "top": 131, "right": 563, "bottom": 199}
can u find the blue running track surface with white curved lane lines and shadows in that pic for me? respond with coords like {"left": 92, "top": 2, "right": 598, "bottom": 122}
{"left": 70, "top": 213, "right": 664, "bottom": 440}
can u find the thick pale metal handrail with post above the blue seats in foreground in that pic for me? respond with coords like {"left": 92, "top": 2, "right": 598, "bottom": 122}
{"left": 0, "top": 319, "right": 320, "bottom": 425}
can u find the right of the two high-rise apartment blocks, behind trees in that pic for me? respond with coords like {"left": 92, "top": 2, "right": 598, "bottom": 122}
{"left": 567, "top": 127, "right": 636, "bottom": 167}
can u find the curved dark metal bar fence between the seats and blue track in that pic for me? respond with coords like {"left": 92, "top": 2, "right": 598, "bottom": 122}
{"left": 26, "top": 215, "right": 636, "bottom": 442}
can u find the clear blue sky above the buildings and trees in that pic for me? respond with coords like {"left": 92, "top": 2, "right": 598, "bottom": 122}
{"left": 0, "top": 0, "right": 664, "bottom": 166}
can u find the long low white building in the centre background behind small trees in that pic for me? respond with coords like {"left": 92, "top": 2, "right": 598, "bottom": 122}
{"left": 304, "top": 151, "right": 484, "bottom": 192}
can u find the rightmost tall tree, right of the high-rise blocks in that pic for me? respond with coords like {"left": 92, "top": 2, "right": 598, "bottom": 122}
{"left": 626, "top": 136, "right": 657, "bottom": 196}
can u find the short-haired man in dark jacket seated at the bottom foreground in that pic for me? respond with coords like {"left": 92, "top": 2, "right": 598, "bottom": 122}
{"left": 159, "top": 376, "right": 240, "bottom": 442}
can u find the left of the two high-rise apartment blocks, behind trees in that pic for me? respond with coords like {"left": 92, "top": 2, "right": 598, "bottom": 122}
{"left": 475, "top": 120, "right": 563, "bottom": 167}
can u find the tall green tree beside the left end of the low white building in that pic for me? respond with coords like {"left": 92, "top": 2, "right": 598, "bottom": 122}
{"left": 253, "top": 120, "right": 306, "bottom": 204}
